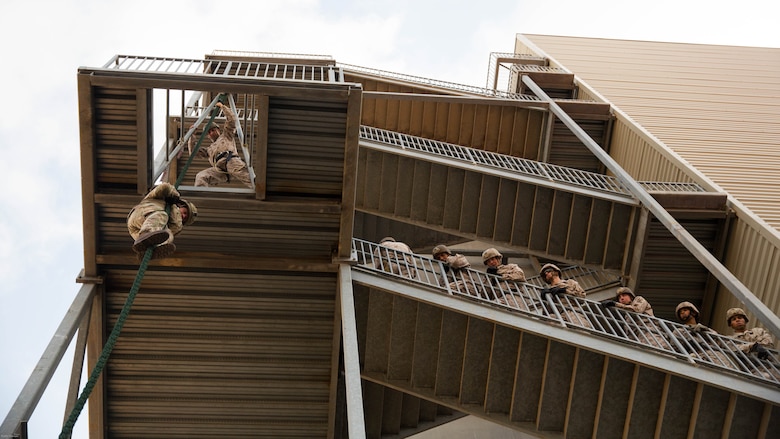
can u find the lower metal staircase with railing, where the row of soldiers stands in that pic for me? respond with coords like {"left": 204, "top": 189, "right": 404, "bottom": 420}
{"left": 353, "top": 241, "right": 780, "bottom": 438}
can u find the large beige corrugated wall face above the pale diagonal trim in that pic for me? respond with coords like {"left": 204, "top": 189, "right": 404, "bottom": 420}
{"left": 525, "top": 35, "right": 780, "bottom": 228}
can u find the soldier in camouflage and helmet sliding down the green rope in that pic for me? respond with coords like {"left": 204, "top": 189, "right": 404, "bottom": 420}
{"left": 127, "top": 183, "right": 198, "bottom": 259}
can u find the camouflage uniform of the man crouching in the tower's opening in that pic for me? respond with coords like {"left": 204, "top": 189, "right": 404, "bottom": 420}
{"left": 195, "top": 105, "right": 254, "bottom": 188}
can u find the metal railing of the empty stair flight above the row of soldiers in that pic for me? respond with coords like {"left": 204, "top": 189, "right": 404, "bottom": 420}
{"left": 360, "top": 125, "right": 704, "bottom": 199}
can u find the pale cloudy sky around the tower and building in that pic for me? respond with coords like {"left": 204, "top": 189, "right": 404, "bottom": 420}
{"left": 0, "top": 0, "right": 780, "bottom": 438}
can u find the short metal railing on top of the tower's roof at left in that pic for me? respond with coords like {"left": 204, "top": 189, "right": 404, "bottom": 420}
{"left": 103, "top": 55, "right": 343, "bottom": 82}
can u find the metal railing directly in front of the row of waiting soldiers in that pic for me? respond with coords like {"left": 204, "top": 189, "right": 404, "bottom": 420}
{"left": 352, "top": 238, "right": 780, "bottom": 386}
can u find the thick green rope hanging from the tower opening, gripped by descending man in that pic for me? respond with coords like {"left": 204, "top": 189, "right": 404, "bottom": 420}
{"left": 59, "top": 94, "right": 222, "bottom": 439}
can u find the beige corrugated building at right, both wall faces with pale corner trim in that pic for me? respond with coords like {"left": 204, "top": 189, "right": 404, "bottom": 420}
{"left": 515, "top": 34, "right": 780, "bottom": 333}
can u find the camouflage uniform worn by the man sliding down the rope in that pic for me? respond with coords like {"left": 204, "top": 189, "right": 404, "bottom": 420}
{"left": 127, "top": 183, "right": 187, "bottom": 244}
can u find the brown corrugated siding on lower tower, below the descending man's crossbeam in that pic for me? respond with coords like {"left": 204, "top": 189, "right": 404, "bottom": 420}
{"left": 104, "top": 268, "right": 336, "bottom": 438}
